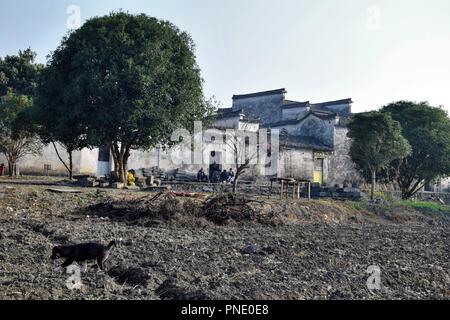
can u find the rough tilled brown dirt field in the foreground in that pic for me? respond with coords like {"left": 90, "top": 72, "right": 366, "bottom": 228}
{"left": 0, "top": 185, "right": 450, "bottom": 299}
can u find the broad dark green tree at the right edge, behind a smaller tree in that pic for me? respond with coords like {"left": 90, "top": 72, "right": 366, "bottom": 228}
{"left": 382, "top": 101, "right": 450, "bottom": 199}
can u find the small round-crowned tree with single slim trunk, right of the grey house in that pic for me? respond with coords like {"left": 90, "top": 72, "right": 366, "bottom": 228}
{"left": 348, "top": 112, "right": 411, "bottom": 200}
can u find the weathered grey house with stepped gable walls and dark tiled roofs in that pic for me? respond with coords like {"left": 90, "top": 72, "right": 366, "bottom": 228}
{"left": 209, "top": 89, "right": 361, "bottom": 185}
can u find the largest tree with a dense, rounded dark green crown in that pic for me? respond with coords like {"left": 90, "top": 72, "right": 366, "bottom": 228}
{"left": 42, "top": 12, "right": 213, "bottom": 181}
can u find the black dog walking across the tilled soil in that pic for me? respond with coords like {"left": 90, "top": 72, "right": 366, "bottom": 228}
{"left": 50, "top": 241, "right": 117, "bottom": 270}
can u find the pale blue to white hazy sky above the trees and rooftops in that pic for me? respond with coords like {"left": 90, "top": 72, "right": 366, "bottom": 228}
{"left": 0, "top": 0, "right": 450, "bottom": 112}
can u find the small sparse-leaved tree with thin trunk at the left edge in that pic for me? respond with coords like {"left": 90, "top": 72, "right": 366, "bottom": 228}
{"left": 0, "top": 92, "right": 42, "bottom": 177}
